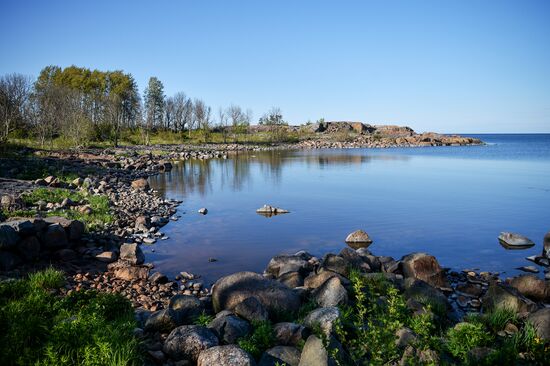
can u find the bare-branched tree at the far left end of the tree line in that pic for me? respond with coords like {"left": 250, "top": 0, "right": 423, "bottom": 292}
{"left": 0, "top": 74, "right": 32, "bottom": 142}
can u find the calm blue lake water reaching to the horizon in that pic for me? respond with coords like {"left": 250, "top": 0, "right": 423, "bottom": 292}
{"left": 149, "top": 134, "right": 550, "bottom": 283}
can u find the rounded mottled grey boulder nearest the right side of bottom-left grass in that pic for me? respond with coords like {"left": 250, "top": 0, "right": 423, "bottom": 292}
{"left": 163, "top": 325, "right": 219, "bottom": 361}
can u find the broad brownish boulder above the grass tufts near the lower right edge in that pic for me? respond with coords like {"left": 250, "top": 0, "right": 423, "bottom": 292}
{"left": 482, "top": 283, "right": 537, "bottom": 313}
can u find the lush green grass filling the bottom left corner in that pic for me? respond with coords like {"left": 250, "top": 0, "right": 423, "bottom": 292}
{"left": 0, "top": 268, "right": 141, "bottom": 365}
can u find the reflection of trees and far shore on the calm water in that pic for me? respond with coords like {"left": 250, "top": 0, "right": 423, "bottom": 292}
{"left": 151, "top": 150, "right": 410, "bottom": 196}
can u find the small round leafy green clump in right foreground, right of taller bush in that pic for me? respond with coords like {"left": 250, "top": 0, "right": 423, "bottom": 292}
{"left": 446, "top": 322, "right": 493, "bottom": 361}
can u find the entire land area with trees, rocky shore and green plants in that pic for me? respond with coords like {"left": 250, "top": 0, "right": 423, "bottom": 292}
{"left": 0, "top": 66, "right": 550, "bottom": 366}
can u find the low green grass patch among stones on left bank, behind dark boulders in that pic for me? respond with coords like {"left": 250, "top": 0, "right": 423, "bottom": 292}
{"left": 8, "top": 188, "right": 113, "bottom": 230}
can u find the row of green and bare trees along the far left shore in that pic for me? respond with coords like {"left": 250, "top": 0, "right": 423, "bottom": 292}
{"left": 0, "top": 66, "right": 286, "bottom": 146}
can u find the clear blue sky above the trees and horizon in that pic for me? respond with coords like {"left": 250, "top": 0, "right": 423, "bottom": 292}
{"left": 0, "top": 0, "right": 550, "bottom": 132}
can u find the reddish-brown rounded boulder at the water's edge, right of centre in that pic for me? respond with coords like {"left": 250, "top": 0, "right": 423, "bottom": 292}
{"left": 401, "top": 253, "right": 449, "bottom": 287}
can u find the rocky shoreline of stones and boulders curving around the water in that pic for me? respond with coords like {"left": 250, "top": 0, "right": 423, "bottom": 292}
{"left": 4, "top": 135, "right": 550, "bottom": 366}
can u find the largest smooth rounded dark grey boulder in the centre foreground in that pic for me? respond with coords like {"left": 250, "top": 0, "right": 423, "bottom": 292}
{"left": 212, "top": 272, "right": 301, "bottom": 314}
